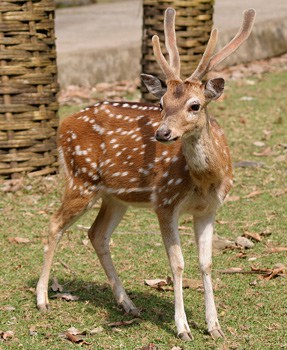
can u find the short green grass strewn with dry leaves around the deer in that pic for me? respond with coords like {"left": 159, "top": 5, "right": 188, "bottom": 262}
{"left": 0, "top": 72, "right": 287, "bottom": 350}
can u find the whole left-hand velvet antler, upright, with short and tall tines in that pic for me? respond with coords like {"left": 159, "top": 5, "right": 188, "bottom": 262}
{"left": 152, "top": 7, "right": 180, "bottom": 80}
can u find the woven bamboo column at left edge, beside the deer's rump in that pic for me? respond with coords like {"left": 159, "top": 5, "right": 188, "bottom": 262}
{"left": 0, "top": 0, "right": 58, "bottom": 178}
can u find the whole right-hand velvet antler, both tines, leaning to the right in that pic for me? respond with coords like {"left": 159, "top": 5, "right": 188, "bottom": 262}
{"left": 190, "top": 9, "right": 255, "bottom": 81}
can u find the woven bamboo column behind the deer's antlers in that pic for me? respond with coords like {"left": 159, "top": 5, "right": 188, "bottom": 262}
{"left": 141, "top": 0, "right": 214, "bottom": 101}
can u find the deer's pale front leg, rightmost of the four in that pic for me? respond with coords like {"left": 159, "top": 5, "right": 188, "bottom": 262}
{"left": 194, "top": 213, "right": 224, "bottom": 339}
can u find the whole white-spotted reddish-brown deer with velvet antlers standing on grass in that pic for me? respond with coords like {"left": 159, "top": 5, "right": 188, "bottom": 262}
{"left": 36, "top": 8, "right": 255, "bottom": 341}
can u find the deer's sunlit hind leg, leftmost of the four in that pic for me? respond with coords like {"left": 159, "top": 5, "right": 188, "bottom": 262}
{"left": 36, "top": 191, "right": 93, "bottom": 311}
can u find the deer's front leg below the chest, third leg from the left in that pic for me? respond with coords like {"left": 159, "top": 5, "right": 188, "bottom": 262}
{"left": 157, "top": 211, "right": 193, "bottom": 341}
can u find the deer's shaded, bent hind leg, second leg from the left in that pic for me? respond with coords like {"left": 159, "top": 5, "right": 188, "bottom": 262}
{"left": 89, "top": 198, "right": 139, "bottom": 315}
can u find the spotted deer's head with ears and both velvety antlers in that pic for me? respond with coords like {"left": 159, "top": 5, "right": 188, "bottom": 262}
{"left": 142, "top": 8, "right": 255, "bottom": 142}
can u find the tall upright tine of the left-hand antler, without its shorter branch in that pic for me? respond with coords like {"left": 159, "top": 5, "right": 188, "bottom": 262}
{"left": 164, "top": 7, "right": 180, "bottom": 76}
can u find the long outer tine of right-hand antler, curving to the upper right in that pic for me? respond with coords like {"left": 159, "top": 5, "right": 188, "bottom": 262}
{"left": 208, "top": 9, "right": 255, "bottom": 71}
